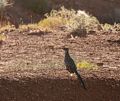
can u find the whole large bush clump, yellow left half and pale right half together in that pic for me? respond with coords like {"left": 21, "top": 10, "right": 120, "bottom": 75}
{"left": 39, "top": 7, "right": 100, "bottom": 33}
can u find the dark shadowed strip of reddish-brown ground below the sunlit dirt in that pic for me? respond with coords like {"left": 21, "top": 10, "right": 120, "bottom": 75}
{"left": 0, "top": 69, "right": 120, "bottom": 101}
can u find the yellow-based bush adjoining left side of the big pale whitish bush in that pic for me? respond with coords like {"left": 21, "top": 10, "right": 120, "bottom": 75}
{"left": 38, "top": 7, "right": 74, "bottom": 28}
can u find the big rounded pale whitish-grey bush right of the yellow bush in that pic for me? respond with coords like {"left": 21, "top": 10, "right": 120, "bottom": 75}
{"left": 68, "top": 10, "right": 100, "bottom": 35}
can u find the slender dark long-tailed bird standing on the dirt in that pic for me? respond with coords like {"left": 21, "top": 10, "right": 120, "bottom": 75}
{"left": 62, "top": 48, "right": 86, "bottom": 89}
